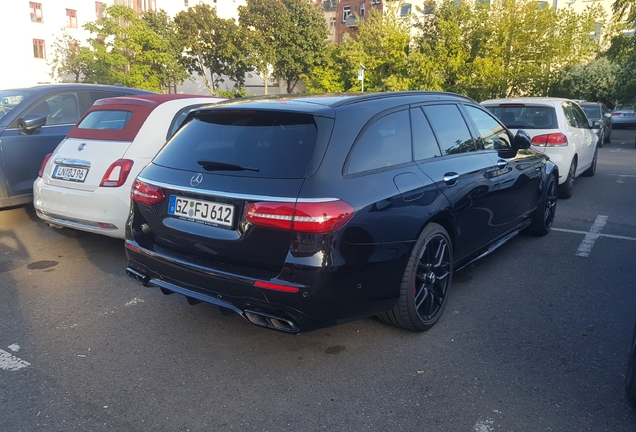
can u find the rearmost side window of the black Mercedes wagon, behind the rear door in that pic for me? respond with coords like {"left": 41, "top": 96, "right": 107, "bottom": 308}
{"left": 347, "top": 110, "right": 411, "bottom": 174}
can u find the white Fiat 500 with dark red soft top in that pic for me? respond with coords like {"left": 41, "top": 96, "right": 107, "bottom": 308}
{"left": 33, "top": 94, "right": 223, "bottom": 238}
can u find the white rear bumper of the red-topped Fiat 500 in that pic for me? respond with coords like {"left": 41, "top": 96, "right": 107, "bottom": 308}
{"left": 33, "top": 178, "right": 130, "bottom": 239}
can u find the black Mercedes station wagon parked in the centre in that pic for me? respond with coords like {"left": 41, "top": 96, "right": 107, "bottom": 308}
{"left": 126, "top": 92, "right": 558, "bottom": 333}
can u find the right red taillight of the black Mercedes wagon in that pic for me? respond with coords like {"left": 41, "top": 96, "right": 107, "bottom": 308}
{"left": 245, "top": 201, "right": 354, "bottom": 234}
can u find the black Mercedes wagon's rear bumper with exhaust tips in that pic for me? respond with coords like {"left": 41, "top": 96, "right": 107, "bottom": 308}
{"left": 126, "top": 240, "right": 406, "bottom": 333}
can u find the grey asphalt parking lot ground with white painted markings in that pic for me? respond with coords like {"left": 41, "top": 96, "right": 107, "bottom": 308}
{"left": 0, "top": 130, "right": 636, "bottom": 432}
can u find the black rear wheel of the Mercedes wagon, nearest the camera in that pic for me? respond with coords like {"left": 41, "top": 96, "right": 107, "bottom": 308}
{"left": 379, "top": 223, "right": 453, "bottom": 331}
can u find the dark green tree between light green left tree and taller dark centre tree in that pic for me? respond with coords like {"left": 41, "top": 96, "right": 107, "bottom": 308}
{"left": 174, "top": 4, "right": 251, "bottom": 95}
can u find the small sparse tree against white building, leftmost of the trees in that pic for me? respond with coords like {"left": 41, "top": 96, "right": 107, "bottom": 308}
{"left": 49, "top": 29, "right": 92, "bottom": 82}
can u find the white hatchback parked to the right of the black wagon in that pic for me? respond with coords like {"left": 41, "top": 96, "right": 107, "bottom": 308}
{"left": 481, "top": 97, "right": 601, "bottom": 198}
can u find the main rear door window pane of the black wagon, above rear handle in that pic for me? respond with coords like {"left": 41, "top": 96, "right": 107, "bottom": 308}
{"left": 423, "top": 105, "right": 476, "bottom": 155}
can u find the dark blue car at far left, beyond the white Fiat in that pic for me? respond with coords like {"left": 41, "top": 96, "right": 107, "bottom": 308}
{"left": 0, "top": 84, "right": 151, "bottom": 208}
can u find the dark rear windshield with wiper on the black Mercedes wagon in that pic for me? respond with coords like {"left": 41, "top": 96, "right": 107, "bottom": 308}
{"left": 154, "top": 111, "right": 317, "bottom": 178}
